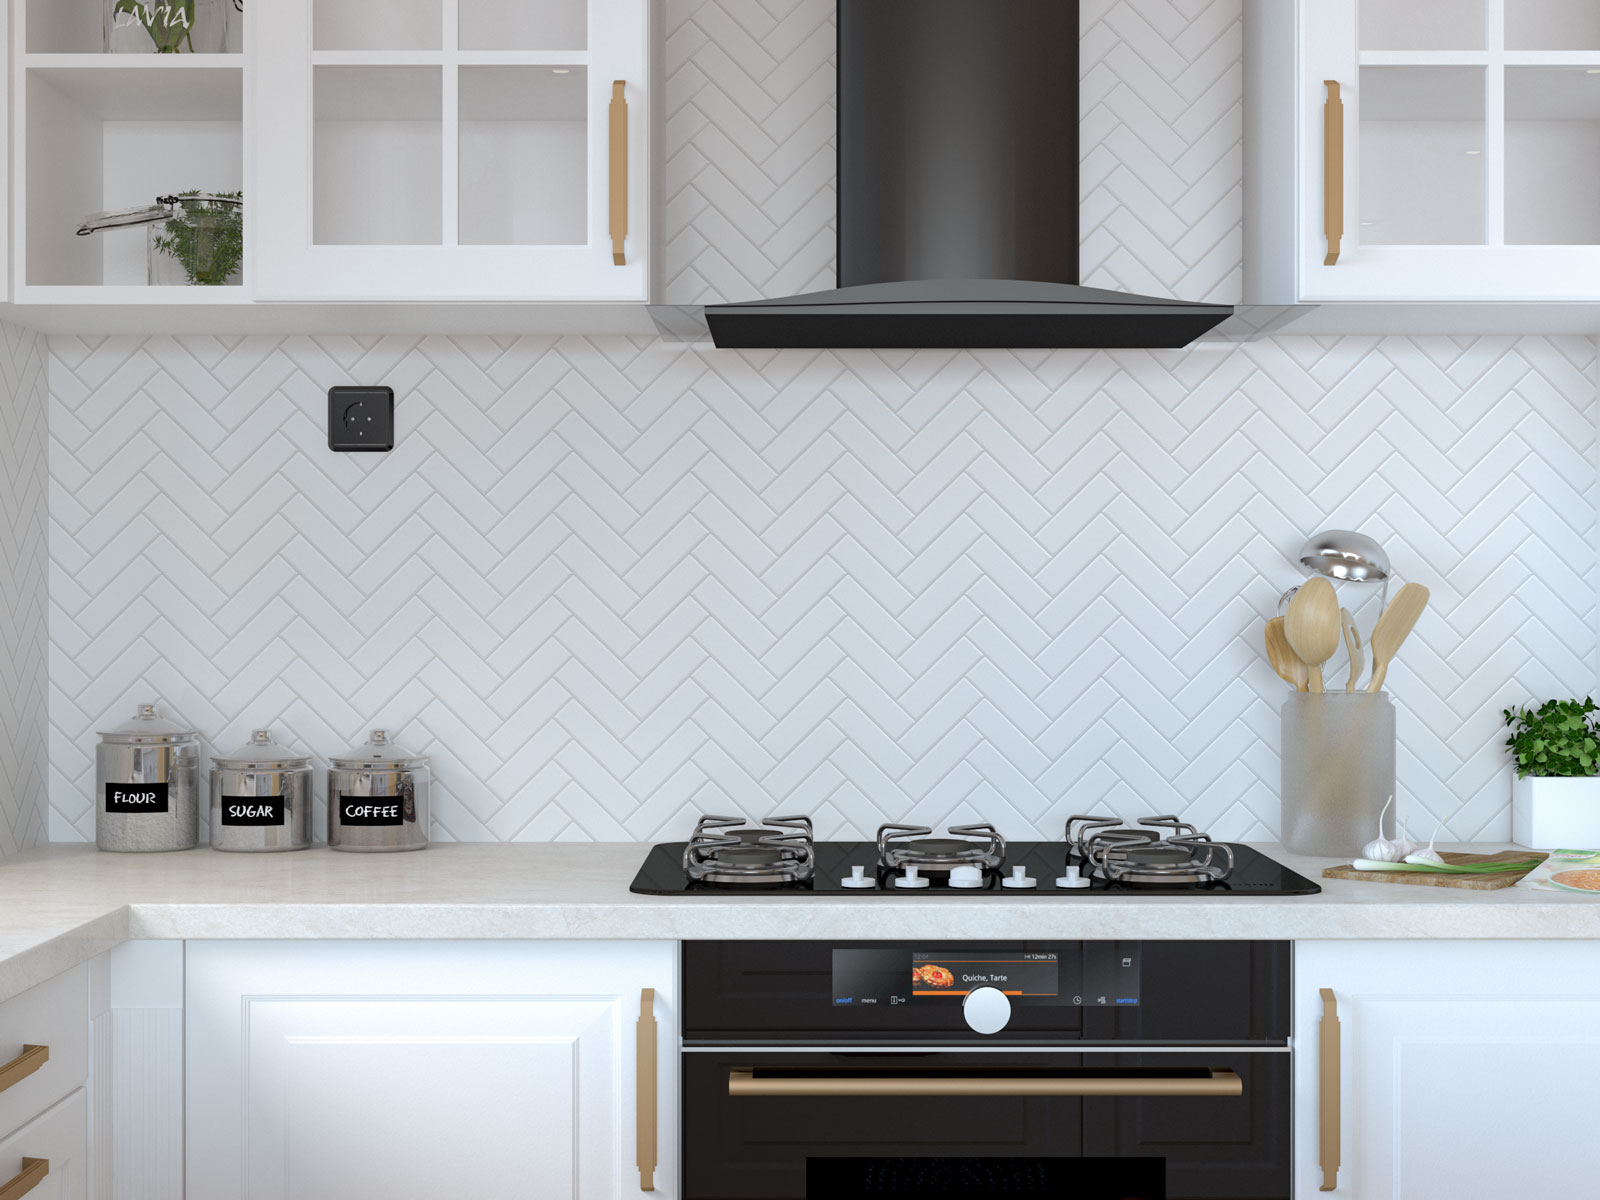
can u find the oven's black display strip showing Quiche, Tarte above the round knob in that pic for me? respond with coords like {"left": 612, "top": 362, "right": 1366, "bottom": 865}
{"left": 834, "top": 942, "right": 1139, "bottom": 1008}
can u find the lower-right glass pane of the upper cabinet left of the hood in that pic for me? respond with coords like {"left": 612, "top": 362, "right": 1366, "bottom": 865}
{"left": 459, "top": 67, "right": 589, "bottom": 246}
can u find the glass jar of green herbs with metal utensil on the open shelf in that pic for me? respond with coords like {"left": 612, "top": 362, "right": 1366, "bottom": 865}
{"left": 78, "top": 192, "right": 245, "bottom": 288}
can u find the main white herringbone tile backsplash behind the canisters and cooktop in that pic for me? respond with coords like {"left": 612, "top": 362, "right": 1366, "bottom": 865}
{"left": 50, "top": 338, "right": 1597, "bottom": 840}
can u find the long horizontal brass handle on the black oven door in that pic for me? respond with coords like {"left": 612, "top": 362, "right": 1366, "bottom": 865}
{"left": 728, "top": 1067, "right": 1245, "bottom": 1096}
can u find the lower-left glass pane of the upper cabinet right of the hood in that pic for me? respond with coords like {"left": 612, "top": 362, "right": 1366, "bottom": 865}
{"left": 1358, "top": 67, "right": 1483, "bottom": 246}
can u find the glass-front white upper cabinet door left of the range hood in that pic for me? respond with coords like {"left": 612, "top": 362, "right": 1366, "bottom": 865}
{"left": 253, "top": 0, "right": 650, "bottom": 301}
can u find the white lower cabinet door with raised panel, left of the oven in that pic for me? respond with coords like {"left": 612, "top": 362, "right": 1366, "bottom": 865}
{"left": 186, "top": 942, "right": 678, "bottom": 1200}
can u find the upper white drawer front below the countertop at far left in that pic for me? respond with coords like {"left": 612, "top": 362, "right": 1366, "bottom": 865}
{"left": 0, "top": 966, "right": 90, "bottom": 1139}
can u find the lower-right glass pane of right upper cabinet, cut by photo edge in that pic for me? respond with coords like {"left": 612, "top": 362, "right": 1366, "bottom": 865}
{"left": 1506, "top": 67, "right": 1600, "bottom": 246}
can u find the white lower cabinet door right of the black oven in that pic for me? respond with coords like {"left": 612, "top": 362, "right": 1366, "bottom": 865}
{"left": 1294, "top": 941, "right": 1600, "bottom": 1200}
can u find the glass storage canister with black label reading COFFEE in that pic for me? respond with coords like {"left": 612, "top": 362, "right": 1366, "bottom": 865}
{"left": 328, "top": 730, "right": 434, "bottom": 853}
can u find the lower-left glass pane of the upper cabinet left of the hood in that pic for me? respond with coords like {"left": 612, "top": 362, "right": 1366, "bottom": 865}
{"left": 312, "top": 67, "right": 445, "bottom": 246}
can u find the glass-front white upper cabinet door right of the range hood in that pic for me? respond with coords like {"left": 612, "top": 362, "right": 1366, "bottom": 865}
{"left": 1245, "top": 0, "right": 1600, "bottom": 304}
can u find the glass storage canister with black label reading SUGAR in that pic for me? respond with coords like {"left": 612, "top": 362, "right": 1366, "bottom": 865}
{"left": 211, "top": 730, "right": 312, "bottom": 853}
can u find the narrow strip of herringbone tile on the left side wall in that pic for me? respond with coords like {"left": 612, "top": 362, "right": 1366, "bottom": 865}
{"left": 0, "top": 322, "right": 48, "bottom": 858}
